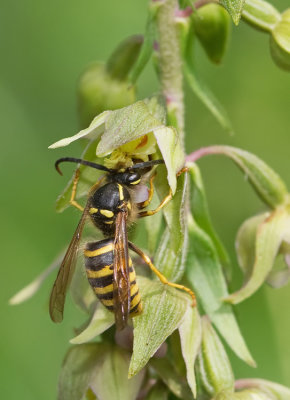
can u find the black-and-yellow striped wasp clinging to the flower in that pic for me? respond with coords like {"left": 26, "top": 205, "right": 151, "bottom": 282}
{"left": 49, "top": 157, "right": 195, "bottom": 330}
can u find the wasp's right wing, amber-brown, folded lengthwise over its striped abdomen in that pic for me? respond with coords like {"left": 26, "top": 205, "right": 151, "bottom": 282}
{"left": 113, "top": 209, "right": 131, "bottom": 330}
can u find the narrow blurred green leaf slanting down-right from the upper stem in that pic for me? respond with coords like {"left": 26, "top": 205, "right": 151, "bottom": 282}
{"left": 184, "top": 61, "right": 233, "bottom": 135}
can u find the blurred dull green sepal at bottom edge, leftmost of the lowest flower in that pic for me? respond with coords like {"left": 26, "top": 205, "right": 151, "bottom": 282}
{"left": 57, "top": 343, "right": 106, "bottom": 400}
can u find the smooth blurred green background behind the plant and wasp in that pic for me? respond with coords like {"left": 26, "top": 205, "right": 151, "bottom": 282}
{"left": 0, "top": 0, "right": 290, "bottom": 400}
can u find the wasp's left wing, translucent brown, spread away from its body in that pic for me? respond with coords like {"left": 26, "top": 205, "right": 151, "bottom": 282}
{"left": 49, "top": 204, "right": 89, "bottom": 322}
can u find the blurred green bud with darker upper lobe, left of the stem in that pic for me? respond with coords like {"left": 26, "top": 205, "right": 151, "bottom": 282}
{"left": 78, "top": 35, "right": 143, "bottom": 128}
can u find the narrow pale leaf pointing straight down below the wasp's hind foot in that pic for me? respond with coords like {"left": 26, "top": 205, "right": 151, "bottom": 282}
{"left": 178, "top": 307, "right": 201, "bottom": 398}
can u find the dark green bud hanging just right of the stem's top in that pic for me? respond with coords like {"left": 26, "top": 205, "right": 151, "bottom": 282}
{"left": 193, "top": 3, "right": 231, "bottom": 64}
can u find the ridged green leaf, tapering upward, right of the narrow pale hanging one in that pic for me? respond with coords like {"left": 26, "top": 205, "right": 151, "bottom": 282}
{"left": 198, "top": 317, "right": 234, "bottom": 396}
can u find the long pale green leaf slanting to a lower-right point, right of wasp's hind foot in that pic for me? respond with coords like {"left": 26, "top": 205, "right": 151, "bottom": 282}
{"left": 186, "top": 216, "right": 255, "bottom": 366}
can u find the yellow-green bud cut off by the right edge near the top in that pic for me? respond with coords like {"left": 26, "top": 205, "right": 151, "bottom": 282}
{"left": 270, "top": 9, "right": 290, "bottom": 71}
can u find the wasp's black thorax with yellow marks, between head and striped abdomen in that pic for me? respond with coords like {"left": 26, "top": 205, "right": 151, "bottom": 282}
{"left": 89, "top": 182, "right": 131, "bottom": 235}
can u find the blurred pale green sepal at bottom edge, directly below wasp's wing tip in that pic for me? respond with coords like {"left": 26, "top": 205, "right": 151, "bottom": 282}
{"left": 90, "top": 344, "right": 145, "bottom": 400}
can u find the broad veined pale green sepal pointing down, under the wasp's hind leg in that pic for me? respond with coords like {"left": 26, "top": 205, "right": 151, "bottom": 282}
{"left": 129, "top": 277, "right": 190, "bottom": 377}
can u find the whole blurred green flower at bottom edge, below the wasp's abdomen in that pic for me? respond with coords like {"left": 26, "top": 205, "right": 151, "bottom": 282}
{"left": 58, "top": 342, "right": 144, "bottom": 400}
